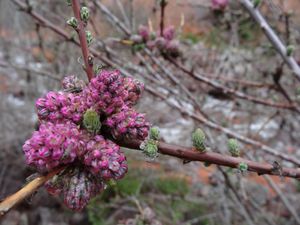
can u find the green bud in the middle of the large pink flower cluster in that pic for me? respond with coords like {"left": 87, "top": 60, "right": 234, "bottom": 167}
{"left": 83, "top": 109, "right": 101, "bottom": 134}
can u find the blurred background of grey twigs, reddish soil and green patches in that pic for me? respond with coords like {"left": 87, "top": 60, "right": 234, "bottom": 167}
{"left": 0, "top": 0, "right": 300, "bottom": 225}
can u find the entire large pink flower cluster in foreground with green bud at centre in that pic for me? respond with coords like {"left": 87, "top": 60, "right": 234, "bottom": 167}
{"left": 23, "top": 70, "right": 150, "bottom": 210}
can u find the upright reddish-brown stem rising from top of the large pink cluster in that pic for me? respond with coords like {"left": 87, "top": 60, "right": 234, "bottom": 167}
{"left": 72, "top": 0, "right": 94, "bottom": 80}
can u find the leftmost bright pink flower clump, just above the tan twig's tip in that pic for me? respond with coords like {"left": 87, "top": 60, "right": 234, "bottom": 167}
{"left": 23, "top": 121, "right": 83, "bottom": 172}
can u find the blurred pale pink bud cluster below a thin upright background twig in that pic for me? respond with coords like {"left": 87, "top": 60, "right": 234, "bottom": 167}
{"left": 131, "top": 25, "right": 181, "bottom": 57}
